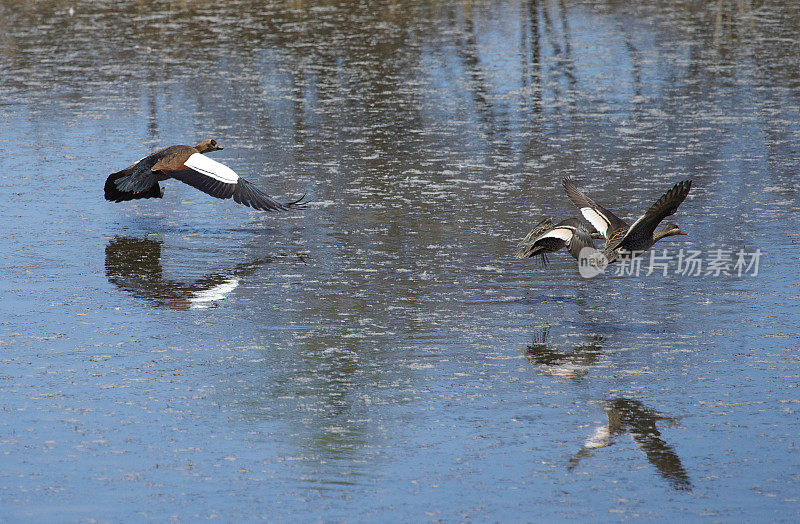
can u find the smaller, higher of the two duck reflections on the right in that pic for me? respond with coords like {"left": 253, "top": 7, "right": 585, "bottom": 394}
{"left": 522, "top": 328, "right": 603, "bottom": 379}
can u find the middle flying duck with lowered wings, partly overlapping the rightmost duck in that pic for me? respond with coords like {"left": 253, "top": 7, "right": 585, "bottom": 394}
{"left": 514, "top": 218, "right": 603, "bottom": 264}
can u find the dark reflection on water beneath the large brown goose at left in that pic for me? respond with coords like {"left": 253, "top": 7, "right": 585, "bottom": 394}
{"left": 106, "top": 237, "right": 270, "bottom": 309}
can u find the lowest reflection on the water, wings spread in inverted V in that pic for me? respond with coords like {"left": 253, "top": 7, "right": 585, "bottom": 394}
{"left": 570, "top": 398, "right": 692, "bottom": 489}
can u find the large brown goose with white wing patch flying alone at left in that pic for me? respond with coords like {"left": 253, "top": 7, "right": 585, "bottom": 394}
{"left": 105, "top": 139, "right": 303, "bottom": 211}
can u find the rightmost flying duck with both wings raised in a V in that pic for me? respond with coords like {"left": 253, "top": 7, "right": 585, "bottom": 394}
{"left": 563, "top": 178, "right": 692, "bottom": 263}
